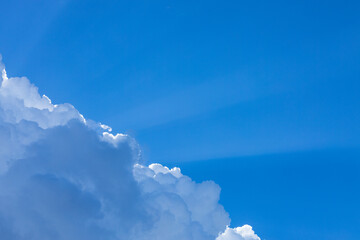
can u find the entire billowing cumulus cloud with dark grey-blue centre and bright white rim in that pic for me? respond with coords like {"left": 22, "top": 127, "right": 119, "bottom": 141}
{"left": 0, "top": 57, "right": 260, "bottom": 240}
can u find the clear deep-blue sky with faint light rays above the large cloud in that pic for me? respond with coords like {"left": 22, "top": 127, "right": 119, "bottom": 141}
{"left": 0, "top": 0, "right": 360, "bottom": 240}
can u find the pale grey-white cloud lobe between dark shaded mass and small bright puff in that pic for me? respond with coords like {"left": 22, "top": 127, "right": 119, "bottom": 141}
{"left": 134, "top": 164, "right": 230, "bottom": 240}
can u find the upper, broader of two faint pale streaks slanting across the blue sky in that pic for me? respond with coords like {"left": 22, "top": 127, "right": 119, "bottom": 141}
{"left": 111, "top": 75, "right": 279, "bottom": 130}
